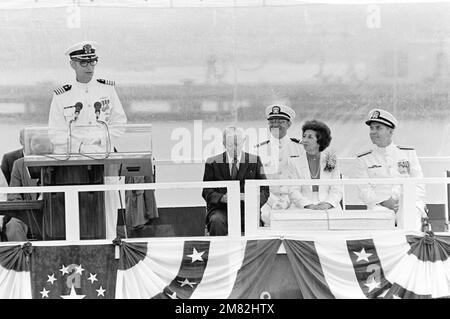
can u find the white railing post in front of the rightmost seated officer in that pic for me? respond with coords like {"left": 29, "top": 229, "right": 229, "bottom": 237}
{"left": 397, "top": 180, "right": 420, "bottom": 231}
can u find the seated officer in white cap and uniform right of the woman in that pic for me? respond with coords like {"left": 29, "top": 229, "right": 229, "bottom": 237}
{"left": 355, "top": 109, "right": 427, "bottom": 230}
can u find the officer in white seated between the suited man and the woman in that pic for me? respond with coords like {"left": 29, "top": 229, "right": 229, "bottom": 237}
{"left": 256, "top": 104, "right": 306, "bottom": 225}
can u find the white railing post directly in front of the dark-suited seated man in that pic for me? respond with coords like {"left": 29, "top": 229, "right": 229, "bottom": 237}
{"left": 227, "top": 181, "right": 241, "bottom": 238}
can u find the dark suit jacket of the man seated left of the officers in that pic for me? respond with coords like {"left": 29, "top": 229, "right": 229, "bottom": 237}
{"left": 202, "top": 152, "right": 269, "bottom": 220}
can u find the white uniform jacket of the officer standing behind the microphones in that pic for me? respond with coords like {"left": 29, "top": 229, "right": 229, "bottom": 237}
{"left": 48, "top": 79, "right": 127, "bottom": 152}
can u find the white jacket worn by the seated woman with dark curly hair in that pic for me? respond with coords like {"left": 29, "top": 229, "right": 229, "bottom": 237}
{"left": 288, "top": 153, "right": 343, "bottom": 210}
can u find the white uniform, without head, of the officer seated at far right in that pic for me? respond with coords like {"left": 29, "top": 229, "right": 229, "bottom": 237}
{"left": 355, "top": 143, "right": 426, "bottom": 230}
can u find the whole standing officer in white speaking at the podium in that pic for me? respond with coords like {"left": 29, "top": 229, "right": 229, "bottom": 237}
{"left": 48, "top": 41, "right": 127, "bottom": 238}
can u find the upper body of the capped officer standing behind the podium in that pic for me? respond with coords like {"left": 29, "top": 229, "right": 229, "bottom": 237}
{"left": 48, "top": 41, "right": 127, "bottom": 152}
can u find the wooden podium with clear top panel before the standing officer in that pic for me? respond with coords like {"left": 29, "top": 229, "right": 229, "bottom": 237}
{"left": 24, "top": 125, "right": 153, "bottom": 240}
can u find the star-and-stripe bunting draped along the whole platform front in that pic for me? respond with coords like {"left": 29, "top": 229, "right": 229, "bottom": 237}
{"left": 0, "top": 231, "right": 450, "bottom": 299}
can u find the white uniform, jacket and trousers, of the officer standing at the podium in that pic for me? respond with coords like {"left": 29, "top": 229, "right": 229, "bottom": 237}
{"left": 48, "top": 79, "right": 127, "bottom": 239}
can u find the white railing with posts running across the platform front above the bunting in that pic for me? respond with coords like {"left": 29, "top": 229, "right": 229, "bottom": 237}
{"left": 0, "top": 178, "right": 450, "bottom": 241}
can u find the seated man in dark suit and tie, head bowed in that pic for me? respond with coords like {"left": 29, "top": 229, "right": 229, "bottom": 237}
{"left": 202, "top": 126, "right": 269, "bottom": 236}
